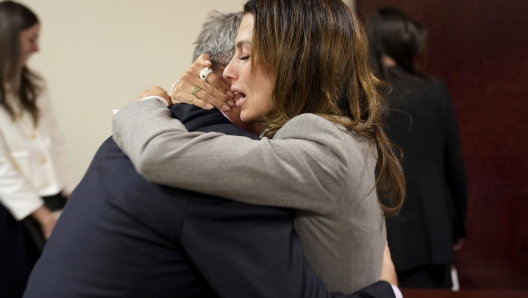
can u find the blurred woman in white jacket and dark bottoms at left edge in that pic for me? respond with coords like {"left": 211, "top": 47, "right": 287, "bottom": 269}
{"left": 0, "top": 1, "right": 75, "bottom": 298}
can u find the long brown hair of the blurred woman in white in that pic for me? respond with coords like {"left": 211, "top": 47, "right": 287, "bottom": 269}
{"left": 0, "top": 1, "right": 41, "bottom": 126}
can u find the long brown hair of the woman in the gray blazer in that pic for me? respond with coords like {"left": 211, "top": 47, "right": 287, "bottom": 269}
{"left": 244, "top": 0, "right": 405, "bottom": 216}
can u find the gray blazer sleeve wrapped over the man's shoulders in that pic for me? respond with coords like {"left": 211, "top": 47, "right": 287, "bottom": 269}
{"left": 113, "top": 99, "right": 347, "bottom": 212}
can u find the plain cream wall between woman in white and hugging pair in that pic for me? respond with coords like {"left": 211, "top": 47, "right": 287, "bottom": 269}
{"left": 20, "top": 0, "right": 245, "bottom": 178}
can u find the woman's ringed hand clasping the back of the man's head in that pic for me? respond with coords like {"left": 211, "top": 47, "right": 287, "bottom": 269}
{"left": 171, "top": 54, "right": 236, "bottom": 112}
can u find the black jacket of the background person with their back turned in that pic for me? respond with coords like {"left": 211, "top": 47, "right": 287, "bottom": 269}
{"left": 386, "top": 67, "right": 467, "bottom": 271}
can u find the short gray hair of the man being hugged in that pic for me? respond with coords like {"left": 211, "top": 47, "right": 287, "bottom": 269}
{"left": 193, "top": 10, "right": 244, "bottom": 66}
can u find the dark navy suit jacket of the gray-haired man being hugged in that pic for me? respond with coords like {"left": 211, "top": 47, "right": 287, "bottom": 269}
{"left": 24, "top": 105, "right": 394, "bottom": 298}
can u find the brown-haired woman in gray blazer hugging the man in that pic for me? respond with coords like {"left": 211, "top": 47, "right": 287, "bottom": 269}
{"left": 114, "top": 0, "right": 404, "bottom": 293}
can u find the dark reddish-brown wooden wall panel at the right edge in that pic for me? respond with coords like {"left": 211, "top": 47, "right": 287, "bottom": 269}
{"left": 357, "top": 0, "right": 528, "bottom": 289}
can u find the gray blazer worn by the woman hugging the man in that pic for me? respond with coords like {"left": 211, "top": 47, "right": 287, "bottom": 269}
{"left": 113, "top": 99, "right": 386, "bottom": 293}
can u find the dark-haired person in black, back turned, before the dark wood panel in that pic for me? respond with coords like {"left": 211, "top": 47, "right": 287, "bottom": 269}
{"left": 367, "top": 8, "right": 467, "bottom": 288}
